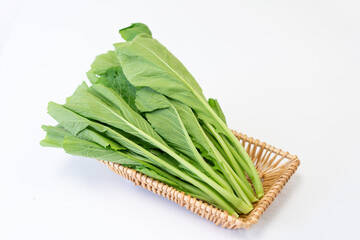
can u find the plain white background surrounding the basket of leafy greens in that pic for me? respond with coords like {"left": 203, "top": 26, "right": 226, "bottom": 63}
{"left": 0, "top": 0, "right": 360, "bottom": 240}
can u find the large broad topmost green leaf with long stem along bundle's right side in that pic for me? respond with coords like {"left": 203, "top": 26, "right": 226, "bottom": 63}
{"left": 114, "top": 35, "right": 264, "bottom": 197}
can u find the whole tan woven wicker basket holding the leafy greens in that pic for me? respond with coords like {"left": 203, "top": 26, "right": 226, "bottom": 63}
{"left": 101, "top": 131, "right": 300, "bottom": 229}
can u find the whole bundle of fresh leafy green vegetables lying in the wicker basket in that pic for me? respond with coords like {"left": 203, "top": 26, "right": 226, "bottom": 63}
{"left": 41, "top": 23, "right": 264, "bottom": 216}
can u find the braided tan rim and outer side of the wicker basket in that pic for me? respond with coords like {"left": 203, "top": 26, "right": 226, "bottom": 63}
{"left": 100, "top": 130, "right": 300, "bottom": 229}
